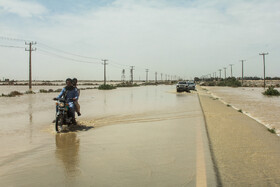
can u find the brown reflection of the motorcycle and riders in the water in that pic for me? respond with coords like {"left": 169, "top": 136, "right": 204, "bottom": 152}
{"left": 55, "top": 133, "right": 80, "bottom": 178}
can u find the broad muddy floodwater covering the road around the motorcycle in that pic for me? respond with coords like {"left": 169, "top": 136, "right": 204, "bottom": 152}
{"left": 0, "top": 86, "right": 216, "bottom": 186}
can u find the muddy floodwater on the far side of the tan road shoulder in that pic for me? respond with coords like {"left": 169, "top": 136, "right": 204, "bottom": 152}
{"left": 205, "top": 87, "right": 280, "bottom": 135}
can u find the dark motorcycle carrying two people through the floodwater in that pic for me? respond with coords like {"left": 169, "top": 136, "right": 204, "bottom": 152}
{"left": 54, "top": 98, "right": 75, "bottom": 133}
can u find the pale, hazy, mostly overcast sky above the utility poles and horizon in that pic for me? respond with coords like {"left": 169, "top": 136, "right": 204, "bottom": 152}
{"left": 0, "top": 0, "right": 280, "bottom": 79}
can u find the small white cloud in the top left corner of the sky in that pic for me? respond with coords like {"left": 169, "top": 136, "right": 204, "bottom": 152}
{"left": 0, "top": 0, "right": 48, "bottom": 18}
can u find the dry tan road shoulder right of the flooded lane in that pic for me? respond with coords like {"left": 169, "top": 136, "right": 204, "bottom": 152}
{"left": 198, "top": 88, "right": 280, "bottom": 186}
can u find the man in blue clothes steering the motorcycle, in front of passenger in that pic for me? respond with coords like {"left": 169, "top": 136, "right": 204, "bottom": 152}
{"left": 54, "top": 78, "right": 79, "bottom": 125}
